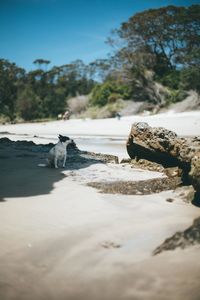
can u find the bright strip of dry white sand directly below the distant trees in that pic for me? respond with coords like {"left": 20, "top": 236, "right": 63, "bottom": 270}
{"left": 0, "top": 111, "right": 200, "bottom": 138}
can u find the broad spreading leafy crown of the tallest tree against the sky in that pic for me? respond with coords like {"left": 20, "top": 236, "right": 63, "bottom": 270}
{"left": 108, "top": 5, "right": 200, "bottom": 75}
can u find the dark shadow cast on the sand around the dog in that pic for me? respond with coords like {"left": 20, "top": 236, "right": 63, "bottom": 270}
{"left": 0, "top": 139, "right": 107, "bottom": 202}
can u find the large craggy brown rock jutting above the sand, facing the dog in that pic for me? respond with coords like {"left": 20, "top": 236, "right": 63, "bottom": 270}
{"left": 127, "top": 122, "right": 200, "bottom": 198}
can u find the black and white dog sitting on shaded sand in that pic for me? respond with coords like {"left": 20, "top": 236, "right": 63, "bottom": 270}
{"left": 47, "top": 135, "right": 73, "bottom": 169}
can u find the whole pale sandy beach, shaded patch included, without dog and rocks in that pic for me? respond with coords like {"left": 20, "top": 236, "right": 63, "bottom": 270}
{"left": 0, "top": 112, "right": 200, "bottom": 300}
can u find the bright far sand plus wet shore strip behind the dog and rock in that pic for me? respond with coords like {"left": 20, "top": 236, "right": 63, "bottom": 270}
{"left": 0, "top": 111, "right": 200, "bottom": 160}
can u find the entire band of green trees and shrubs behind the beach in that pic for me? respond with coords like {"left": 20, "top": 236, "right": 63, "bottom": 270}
{"left": 0, "top": 5, "right": 200, "bottom": 121}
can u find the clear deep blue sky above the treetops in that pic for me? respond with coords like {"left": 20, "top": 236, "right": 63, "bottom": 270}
{"left": 0, "top": 0, "right": 200, "bottom": 70}
